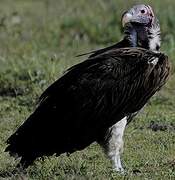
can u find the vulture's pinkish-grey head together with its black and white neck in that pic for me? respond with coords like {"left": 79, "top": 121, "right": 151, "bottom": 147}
{"left": 122, "top": 4, "right": 161, "bottom": 51}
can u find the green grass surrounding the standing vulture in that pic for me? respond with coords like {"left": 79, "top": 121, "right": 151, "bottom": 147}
{"left": 0, "top": 0, "right": 175, "bottom": 180}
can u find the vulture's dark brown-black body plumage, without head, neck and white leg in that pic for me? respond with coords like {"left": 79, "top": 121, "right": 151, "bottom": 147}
{"left": 6, "top": 48, "right": 169, "bottom": 167}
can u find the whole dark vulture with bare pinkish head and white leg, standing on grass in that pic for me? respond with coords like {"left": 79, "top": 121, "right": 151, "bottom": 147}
{"left": 6, "top": 5, "right": 169, "bottom": 171}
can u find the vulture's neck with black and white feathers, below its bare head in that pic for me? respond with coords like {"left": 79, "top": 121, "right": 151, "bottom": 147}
{"left": 124, "top": 23, "right": 161, "bottom": 52}
